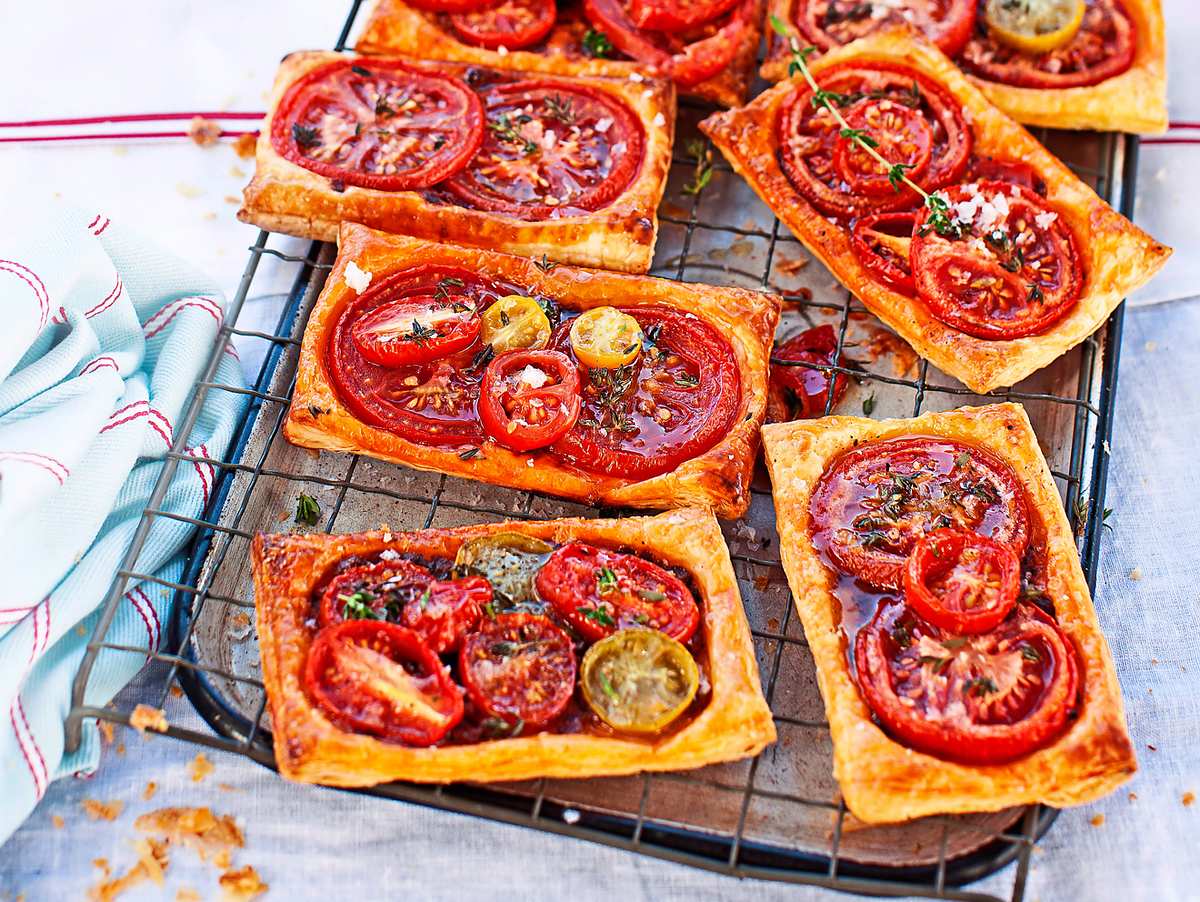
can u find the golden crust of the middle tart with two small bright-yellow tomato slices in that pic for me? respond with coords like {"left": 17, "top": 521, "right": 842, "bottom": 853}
{"left": 283, "top": 223, "right": 780, "bottom": 517}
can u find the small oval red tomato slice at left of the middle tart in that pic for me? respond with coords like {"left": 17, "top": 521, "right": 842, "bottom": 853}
{"left": 350, "top": 294, "right": 480, "bottom": 367}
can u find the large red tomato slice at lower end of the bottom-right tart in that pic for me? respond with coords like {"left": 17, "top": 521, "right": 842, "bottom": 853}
{"left": 854, "top": 600, "right": 1080, "bottom": 764}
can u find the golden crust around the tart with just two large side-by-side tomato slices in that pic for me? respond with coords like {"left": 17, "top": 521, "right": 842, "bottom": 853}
{"left": 238, "top": 50, "right": 676, "bottom": 272}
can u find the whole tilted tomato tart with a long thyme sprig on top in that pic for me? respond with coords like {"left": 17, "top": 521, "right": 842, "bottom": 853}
{"left": 701, "top": 29, "right": 1170, "bottom": 392}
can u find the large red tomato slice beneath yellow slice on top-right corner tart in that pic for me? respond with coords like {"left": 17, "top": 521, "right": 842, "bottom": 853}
{"left": 958, "top": 0, "right": 1138, "bottom": 89}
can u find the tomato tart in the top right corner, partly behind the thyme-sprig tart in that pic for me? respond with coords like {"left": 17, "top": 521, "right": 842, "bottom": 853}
{"left": 762, "top": 0, "right": 1166, "bottom": 132}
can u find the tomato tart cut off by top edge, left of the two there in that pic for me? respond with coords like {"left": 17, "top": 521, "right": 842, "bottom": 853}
{"left": 355, "top": 0, "right": 766, "bottom": 107}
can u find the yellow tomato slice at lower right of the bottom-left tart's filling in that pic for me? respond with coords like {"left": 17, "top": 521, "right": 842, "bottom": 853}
{"left": 580, "top": 629, "right": 700, "bottom": 734}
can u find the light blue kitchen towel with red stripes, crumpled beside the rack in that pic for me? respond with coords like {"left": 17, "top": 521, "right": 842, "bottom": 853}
{"left": 0, "top": 203, "right": 245, "bottom": 843}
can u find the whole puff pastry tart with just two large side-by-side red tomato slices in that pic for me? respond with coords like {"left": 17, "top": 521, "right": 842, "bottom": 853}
{"left": 238, "top": 52, "right": 674, "bottom": 272}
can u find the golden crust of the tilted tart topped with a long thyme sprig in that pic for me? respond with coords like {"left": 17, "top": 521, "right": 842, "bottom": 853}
{"left": 700, "top": 29, "right": 1171, "bottom": 393}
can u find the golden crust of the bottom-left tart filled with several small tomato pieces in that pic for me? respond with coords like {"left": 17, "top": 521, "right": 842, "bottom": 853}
{"left": 253, "top": 510, "right": 775, "bottom": 786}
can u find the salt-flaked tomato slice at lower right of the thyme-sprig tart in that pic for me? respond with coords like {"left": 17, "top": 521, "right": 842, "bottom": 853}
{"left": 910, "top": 181, "right": 1084, "bottom": 341}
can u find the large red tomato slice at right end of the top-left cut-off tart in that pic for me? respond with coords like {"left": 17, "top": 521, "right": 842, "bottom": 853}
{"left": 583, "top": 0, "right": 758, "bottom": 88}
